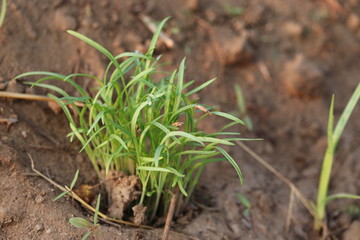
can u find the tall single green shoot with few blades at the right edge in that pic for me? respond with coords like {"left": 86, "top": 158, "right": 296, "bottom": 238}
{"left": 315, "top": 83, "right": 360, "bottom": 229}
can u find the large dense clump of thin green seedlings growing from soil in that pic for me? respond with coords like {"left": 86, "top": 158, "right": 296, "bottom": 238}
{"left": 17, "top": 19, "right": 248, "bottom": 219}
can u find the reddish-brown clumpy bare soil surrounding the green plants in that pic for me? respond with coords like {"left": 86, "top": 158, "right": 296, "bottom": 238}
{"left": 0, "top": 0, "right": 360, "bottom": 240}
